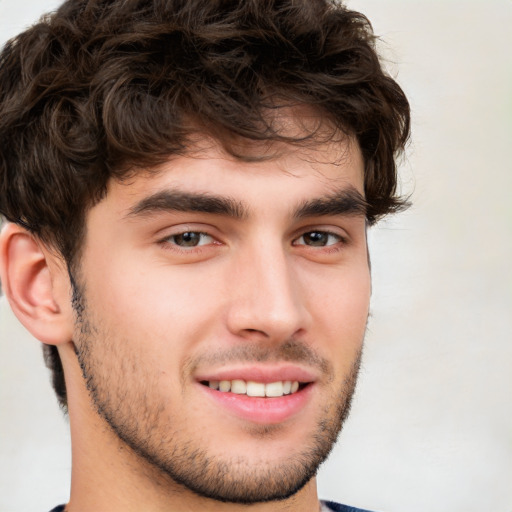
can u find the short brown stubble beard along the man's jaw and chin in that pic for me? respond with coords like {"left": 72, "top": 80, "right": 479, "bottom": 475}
{"left": 73, "top": 285, "right": 361, "bottom": 504}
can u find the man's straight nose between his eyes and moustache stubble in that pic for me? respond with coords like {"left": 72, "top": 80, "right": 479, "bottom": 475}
{"left": 227, "top": 239, "right": 309, "bottom": 342}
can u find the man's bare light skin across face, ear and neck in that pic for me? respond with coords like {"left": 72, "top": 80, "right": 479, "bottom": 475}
{"left": 1, "top": 131, "right": 371, "bottom": 512}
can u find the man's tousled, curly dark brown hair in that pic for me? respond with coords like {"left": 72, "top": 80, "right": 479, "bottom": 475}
{"left": 0, "top": 0, "right": 410, "bottom": 408}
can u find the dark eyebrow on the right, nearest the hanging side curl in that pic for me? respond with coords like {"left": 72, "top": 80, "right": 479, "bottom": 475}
{"left": 294, "top": 187, "right": 368, "bottom": 219}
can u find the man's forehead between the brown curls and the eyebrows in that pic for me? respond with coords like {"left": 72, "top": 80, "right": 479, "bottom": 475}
{"left": 107, "top": 135, "right": 364, "bottom": 212}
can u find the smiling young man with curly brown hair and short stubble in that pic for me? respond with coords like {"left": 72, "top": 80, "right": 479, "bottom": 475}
{"left": 0, "top": 0, "right": 409, "bottom": 512}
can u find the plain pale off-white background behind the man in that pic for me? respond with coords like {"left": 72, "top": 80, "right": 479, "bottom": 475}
{"left": 0, "top": 0, "right": 512, "bottom": 512}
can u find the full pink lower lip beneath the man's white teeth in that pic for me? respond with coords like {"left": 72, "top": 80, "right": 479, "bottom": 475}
{"left": 198, "top": 384, "right": 314, "bottom": 425}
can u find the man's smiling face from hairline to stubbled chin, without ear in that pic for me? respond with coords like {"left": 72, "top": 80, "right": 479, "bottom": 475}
{"left": 74, "top": 133, "right": 370, "bottom": 503}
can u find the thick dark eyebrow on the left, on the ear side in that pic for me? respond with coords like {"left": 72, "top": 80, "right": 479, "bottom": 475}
{"left": 126, "top": 190, "right": 247, "bottom": 219}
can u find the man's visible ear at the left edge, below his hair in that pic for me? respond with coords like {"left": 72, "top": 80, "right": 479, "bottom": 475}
{"left": 0, "top": 223, "right": 73, "bottom": 345}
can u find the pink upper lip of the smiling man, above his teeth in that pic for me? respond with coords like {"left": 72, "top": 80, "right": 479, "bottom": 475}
{"left": 195, "top": 364, "right": 317, "bottom": 384}
